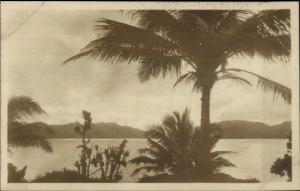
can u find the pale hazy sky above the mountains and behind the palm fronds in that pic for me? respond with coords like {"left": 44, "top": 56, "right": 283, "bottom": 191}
{"left": 1, "top": 3, "right": 291, "bottom": 129}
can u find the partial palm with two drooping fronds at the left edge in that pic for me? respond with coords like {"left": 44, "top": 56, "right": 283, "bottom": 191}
{"left": 8, "top": 96, "right": 53, "bottom": 152}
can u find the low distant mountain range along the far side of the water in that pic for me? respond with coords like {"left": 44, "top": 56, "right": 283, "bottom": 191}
{"left": 51, "top": 120, "right": 291, "bottom": 139}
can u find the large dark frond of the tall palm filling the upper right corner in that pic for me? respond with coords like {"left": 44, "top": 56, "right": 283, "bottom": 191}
{"left": 228, "top": 9, "right": 291, "bottom": 60}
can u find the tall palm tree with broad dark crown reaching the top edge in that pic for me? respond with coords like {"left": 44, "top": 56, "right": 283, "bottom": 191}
{"left": 64, "top": 10, "right": 291, "bottom": 172}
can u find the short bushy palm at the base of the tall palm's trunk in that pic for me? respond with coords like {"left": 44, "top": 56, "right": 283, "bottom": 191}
{"left": 130, "top": 109, "right": 234, "bottom": 180}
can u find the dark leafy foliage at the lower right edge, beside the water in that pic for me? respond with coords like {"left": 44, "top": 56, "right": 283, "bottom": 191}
{"left": 270, "top": 133, "right": 292, "bottom": 181}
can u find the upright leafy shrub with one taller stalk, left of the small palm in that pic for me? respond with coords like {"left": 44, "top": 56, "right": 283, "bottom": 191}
{"left": 74, "top": 111, "right": 129, "bottom": 182}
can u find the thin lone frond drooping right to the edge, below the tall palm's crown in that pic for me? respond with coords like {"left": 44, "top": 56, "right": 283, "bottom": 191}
{"left": 226, "top": 68, "right": 292, "bottom": 104}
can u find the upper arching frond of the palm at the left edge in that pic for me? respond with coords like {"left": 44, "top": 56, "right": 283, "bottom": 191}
{"left": 7, "top": 96, "right": 46, "bottom": 121}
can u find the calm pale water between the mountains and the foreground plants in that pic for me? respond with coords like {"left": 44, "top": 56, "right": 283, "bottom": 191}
{"left": 9, "top": 139, "right": 287, "bottom": 182}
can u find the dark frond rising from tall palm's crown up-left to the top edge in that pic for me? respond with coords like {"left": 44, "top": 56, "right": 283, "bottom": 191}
{"left": 132, "top": 10, "right": 211, "bottom": 60}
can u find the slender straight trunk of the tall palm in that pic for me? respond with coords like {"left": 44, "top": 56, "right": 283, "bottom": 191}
{"left": 200, "top": 85, "right": 212, "bottom": 175}
